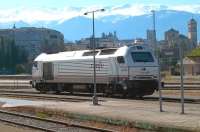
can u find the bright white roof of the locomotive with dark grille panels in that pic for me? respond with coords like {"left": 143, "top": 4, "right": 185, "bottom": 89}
{"left": 34, "top": 46, "right": 150, "bottom": 62}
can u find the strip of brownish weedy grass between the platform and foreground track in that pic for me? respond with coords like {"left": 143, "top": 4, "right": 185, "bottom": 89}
{"left": 5, "top": 107, "right": 196, "bottom": 132}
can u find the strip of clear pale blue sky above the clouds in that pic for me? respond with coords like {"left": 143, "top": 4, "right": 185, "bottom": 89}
{"left": 0, "top": 0, "right": 200, "bottom": 8}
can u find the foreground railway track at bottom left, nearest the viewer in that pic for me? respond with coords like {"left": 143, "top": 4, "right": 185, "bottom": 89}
{"left": 0, "top": 110, "right": 114, "bottom": 132}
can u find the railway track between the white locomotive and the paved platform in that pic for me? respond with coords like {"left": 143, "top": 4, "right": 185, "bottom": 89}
{"left": 0, "top": 89, "right": 200, "bottom": 104}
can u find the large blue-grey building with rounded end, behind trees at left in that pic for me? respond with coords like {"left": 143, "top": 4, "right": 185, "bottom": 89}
{"left": 0, "top": 26, "right": 64, "bottom": 61}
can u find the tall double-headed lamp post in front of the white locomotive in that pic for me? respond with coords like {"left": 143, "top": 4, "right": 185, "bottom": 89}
{"left": 84, "top": 9, "right": 105, "bottom": 105}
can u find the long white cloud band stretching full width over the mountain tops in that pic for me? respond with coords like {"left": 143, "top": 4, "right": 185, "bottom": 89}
{"left": 0, "top": 4, "right": 200, "bottom": 23}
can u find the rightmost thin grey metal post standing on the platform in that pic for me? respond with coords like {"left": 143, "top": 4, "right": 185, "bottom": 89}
{"left": 179, "top": 43, "right": 185, "bottom": 114}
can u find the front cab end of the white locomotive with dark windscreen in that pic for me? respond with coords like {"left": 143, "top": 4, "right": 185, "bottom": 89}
{"left": 116, "top": 45, "right": 159, "bottom": 97}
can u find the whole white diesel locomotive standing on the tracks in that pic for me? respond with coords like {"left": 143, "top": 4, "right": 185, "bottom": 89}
{"left": 32, "top": 45, "right": 159, "bottom": 96}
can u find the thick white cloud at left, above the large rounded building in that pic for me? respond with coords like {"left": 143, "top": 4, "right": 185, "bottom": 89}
{"left": 0, "top": 8, "right": 79, "bottom": 23}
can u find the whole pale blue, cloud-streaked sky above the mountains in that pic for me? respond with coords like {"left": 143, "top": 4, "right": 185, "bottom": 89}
{"left": 0, "top": 0, "right": 200, "bottom": 23}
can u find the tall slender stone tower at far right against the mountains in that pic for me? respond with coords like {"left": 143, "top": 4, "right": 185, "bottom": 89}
{"left": 188, "top": 18, "right": 197, "bottom": 48}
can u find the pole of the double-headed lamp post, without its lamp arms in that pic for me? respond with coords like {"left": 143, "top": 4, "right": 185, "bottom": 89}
{"left": 92, "top": 12, "right": 98, "bottom": 105}
